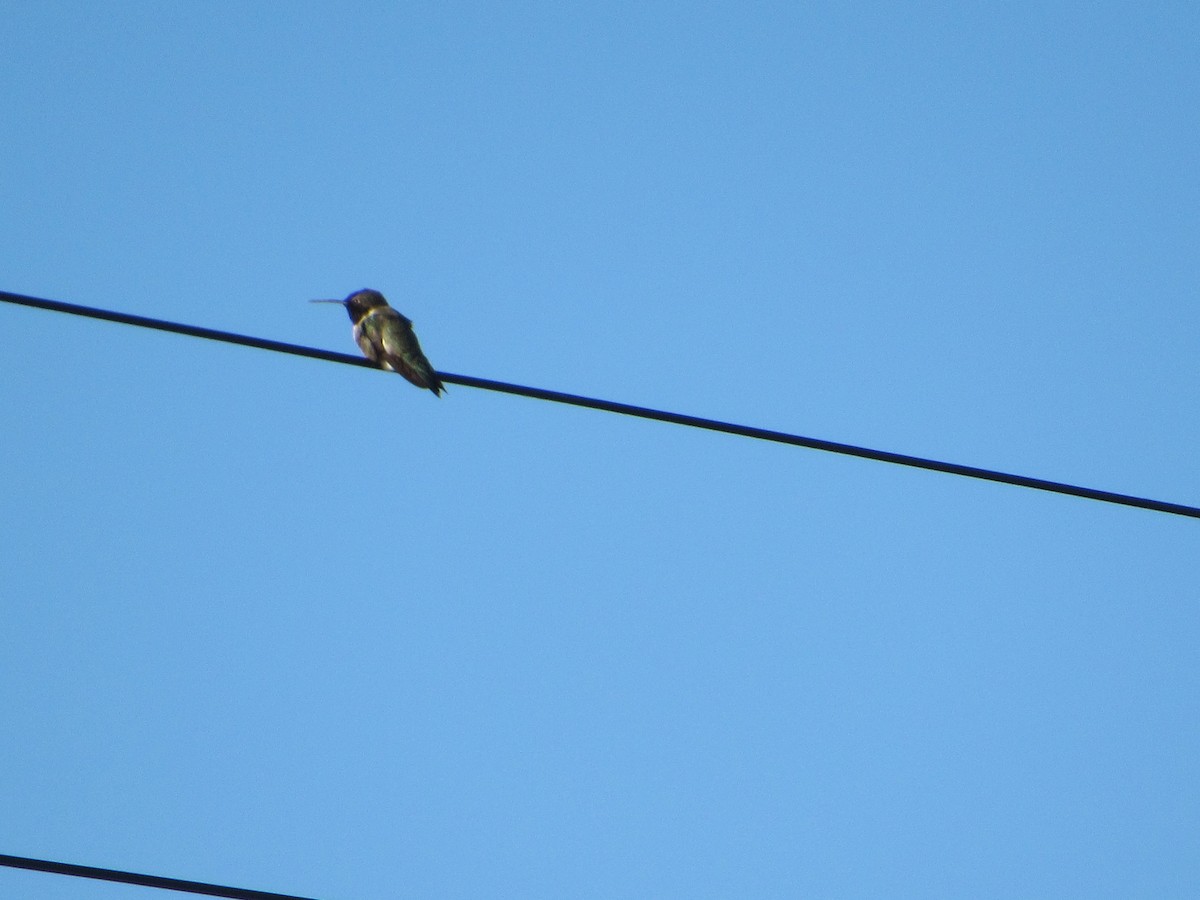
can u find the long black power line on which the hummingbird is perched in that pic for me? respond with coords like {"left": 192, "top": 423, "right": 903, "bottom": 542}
{"left": 0, "top": 290, "right": 1200, "bottom": 518}
